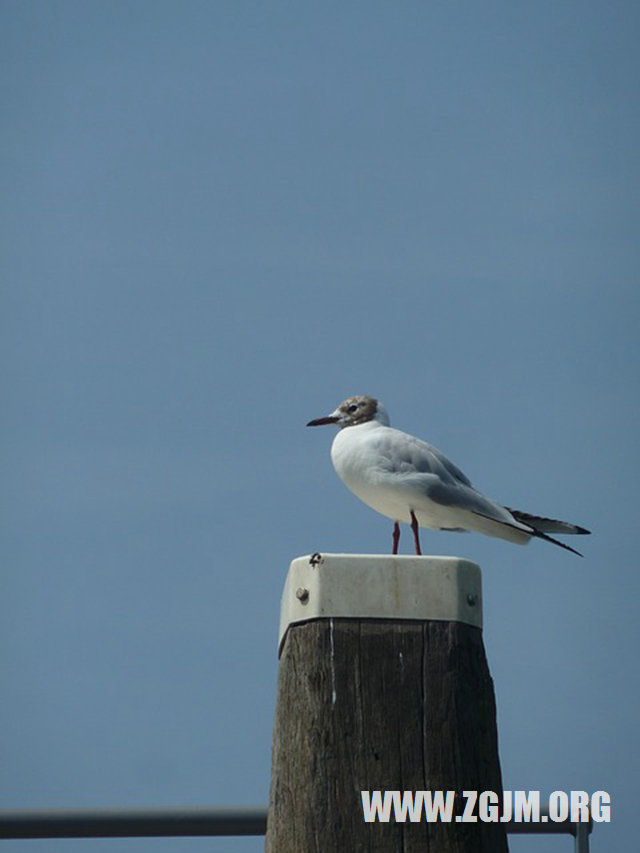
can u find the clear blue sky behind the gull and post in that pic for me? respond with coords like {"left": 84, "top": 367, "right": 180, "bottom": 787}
{"left": 0, "top": 0, "right": 640, "bottom": 853}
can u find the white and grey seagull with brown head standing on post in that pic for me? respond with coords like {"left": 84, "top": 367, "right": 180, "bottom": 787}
{"left": 307, "top": 394, "right": 590, "bottom": 557}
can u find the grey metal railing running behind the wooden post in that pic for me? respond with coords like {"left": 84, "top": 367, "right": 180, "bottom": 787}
{"left": 0, "top": 806, "right": 592, "bottom": 853}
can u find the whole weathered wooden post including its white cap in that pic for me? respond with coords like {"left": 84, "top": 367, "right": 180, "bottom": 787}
{"left": 266, "top": 555, "right": 507, "bottom": 853}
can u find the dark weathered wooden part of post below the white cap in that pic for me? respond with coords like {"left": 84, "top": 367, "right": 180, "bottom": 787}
{"left": 266, "top": 619, "right": 507, "bottom": 853}
